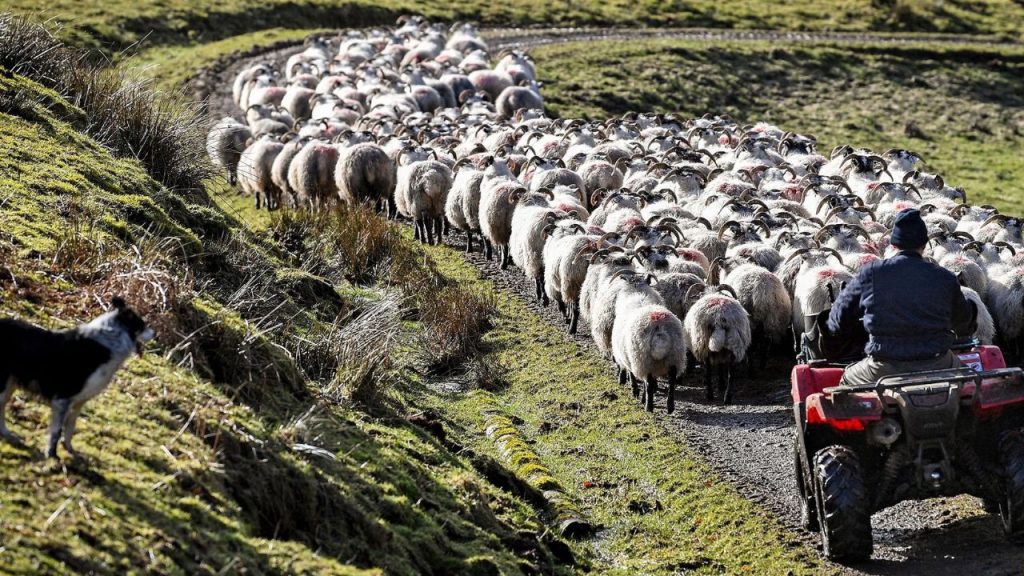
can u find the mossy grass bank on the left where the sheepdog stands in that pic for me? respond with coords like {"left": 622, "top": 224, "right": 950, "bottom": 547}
{"left": 0, "top": 65, "right": 571, "bottom": 574}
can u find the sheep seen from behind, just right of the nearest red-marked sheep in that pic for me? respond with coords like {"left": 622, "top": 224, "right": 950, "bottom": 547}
{"left": 683, "top": 284, "right": 751, "bottom": 404}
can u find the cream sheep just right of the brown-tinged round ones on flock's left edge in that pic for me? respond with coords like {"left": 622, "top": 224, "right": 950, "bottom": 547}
{"left": 394, "top": 155, "right": 453, "bottom": 244}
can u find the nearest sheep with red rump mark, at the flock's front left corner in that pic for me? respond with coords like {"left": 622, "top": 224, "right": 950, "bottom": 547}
{"left": 611, "top": 271, "right": 686, "bottom": 414}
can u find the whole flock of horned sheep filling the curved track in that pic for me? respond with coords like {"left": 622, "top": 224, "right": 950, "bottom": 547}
{"left": 208, "top": 17, "right": 1024, "bottom": 412}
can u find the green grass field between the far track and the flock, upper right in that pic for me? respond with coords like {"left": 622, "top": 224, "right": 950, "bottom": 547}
{"left": 534, "top": 41, "right": 1024, "bottom": 213}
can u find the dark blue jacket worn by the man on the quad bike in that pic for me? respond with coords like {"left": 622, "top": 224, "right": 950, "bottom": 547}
{"left": 828, "top": 251, "right": 975, "bottom": 361}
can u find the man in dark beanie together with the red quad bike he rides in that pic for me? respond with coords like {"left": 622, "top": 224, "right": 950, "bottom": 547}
{"left": 792, "top": 209, "right": 1024, "bottom": 562}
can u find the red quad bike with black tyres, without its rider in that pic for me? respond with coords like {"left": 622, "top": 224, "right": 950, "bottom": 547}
{"left": 792, "top": 341, "right": 1024, "bottom": 562}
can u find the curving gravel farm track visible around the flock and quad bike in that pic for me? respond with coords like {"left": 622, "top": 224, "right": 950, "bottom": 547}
{"left": 189, "top": 29, "right": 1024, "bottom": 576}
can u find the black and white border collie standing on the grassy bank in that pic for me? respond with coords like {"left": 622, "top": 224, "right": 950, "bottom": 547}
{"left": 0, "top": 298, "right": 153, "bottom": 458}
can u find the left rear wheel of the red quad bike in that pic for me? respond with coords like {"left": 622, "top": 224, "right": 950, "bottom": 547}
{"left": 814, "top": 445, "right": 874, "bottom": 562}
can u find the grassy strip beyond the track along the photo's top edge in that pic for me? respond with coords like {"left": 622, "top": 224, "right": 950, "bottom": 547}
{"left": 6, "top": 0, "right": 1024, "bottom": 54}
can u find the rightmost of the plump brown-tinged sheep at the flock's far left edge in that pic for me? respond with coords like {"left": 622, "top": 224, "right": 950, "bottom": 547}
{"left": 334, "top": 142, "right": 396, "bottom": 214}
